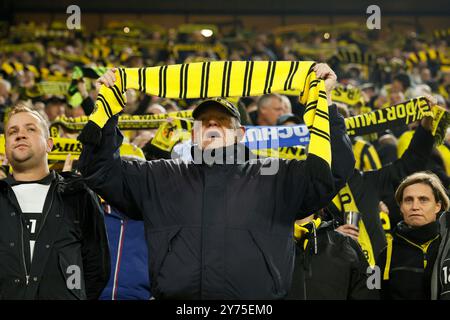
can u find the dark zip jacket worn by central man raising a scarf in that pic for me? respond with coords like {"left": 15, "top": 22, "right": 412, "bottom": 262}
{"left": 79, "top": 107, "right": 354, "bottom": 299}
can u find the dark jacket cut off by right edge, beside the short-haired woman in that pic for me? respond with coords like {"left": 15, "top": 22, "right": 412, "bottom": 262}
{"left": 431, "top": 212, "right": 450, "bottom": 300}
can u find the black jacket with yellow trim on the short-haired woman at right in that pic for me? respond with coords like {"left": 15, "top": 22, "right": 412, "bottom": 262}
{"left": 379, "top": 221, "right": 440, "bottom": 300}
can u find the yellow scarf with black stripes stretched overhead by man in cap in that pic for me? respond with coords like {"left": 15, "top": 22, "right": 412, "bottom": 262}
{"left": 79, "top": 61, "right": 331, "bottom": 165}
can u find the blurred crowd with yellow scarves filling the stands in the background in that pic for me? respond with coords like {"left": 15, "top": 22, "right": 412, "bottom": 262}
{"left": 0, "top": 12, "right": 450, "bottom": 160}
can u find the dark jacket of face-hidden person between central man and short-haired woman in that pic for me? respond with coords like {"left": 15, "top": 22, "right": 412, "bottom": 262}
{"left": 288, "top": 221, "right": 379, "bottom": 300}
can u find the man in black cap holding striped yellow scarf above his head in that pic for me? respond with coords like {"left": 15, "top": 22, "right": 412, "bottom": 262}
{"left": 79, "top": 62, "right": 354, "bottom": 299}
